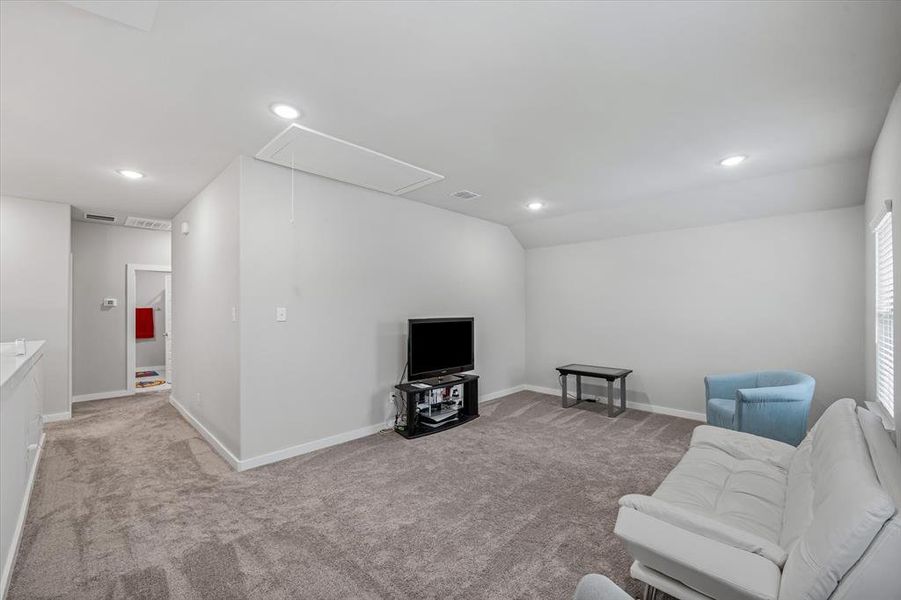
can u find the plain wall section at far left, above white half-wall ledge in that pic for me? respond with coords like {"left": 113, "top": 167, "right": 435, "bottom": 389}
{"left": 0, "top": 196, "right": 71, "bottom": 415}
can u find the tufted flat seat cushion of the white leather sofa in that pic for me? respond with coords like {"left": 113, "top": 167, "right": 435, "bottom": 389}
{"left": 653, "top": 425, "right": 795, "bottom": 543}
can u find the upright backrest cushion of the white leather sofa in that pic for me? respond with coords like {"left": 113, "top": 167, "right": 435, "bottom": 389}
{"left": 779, "top": 398, "right": 895, "bottom": 600}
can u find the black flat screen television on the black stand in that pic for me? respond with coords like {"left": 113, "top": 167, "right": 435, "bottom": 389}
{"left": 407, "top": 317, "right": 475, "bottom": 381}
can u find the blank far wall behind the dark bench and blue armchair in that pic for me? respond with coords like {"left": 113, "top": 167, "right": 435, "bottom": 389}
{"left": 526, "top": 206, "right": 864, "bottom": 417}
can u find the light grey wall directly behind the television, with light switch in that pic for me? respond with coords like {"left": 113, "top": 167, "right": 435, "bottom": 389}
{"left": 237, "top": 158, "right": 525, "bottom": 458}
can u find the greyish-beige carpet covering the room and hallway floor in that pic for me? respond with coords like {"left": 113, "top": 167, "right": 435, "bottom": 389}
{"left": 9, "top": 392, "right": 697, "bottom": 600}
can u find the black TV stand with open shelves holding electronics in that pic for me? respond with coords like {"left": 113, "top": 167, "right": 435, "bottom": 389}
{"left": 394, "top": 375, "right": 479, "bottom": 439}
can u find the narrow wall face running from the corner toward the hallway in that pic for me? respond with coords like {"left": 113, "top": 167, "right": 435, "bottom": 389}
{"left": 171, "top": 159, "right": 241, "bottom": 458}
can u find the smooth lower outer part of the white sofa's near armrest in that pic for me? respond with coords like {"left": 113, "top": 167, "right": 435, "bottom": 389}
{"left": 614, "top": 506, "right": 782, "bottom": 600}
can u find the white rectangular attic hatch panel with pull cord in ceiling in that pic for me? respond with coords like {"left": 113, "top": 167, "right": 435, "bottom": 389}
{"left": 256, "top": 123, "right": 444, "bottom": 196}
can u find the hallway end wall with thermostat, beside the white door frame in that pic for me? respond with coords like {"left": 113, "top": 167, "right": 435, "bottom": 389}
{"left": 72, "top": 221, "right": 171, "bottom": 396}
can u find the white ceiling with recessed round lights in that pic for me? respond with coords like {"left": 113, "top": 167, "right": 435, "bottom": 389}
{"left": 0, "top": 2, "right": 901, "bottom": 246}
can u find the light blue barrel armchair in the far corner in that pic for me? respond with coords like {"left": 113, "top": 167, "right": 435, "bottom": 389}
{"left": 704, "top": 371, "right": 816, "bottom": 446}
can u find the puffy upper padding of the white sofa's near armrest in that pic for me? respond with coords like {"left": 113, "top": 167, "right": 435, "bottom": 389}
{"left": 619, "top": 494, "right": 788, "bottom": 568}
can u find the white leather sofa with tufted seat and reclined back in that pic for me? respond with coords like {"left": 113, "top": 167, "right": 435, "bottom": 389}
{"left": 615, "top": 398, "right": 901, "bottom": 600}
